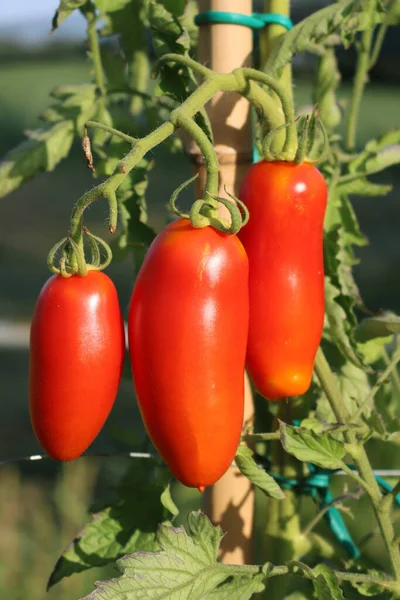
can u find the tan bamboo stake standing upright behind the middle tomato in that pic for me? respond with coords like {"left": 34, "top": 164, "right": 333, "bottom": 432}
{"left": 187, "top": 0, "right": 254, "bottom": 564}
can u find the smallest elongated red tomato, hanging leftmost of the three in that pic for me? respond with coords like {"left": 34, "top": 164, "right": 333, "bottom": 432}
{"left": 29, "top": 271, "right": 125, "bottom": 460}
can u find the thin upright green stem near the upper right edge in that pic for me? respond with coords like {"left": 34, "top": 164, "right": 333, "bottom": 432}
{"left": 346, "top": 29, "right": 373, "bottom": 151}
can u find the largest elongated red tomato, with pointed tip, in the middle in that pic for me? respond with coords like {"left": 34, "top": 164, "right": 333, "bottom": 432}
{"left": 128, "top": 219, "right": 248, "bottom": 490}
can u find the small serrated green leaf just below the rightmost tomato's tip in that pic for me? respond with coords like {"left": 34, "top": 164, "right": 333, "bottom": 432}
{"left": 280, "top": 423, "right": 346, "bottom": 469}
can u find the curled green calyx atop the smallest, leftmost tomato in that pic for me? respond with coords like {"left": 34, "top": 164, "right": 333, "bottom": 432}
{"left": 47, "top": 227, "right": 112, "bottom": 278}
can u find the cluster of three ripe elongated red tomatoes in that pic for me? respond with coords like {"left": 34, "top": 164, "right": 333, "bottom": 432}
{"left": 30, "top": 161, "right": 327, "bottom": 490}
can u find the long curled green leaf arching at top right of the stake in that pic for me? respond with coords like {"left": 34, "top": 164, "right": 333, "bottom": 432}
{"left": 264, "top": 0, "right": 384, "bottom": 78}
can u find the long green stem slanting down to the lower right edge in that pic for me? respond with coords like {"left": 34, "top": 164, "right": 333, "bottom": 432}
{"left": 315, "top": 348, "right": 400, "bottom": 582}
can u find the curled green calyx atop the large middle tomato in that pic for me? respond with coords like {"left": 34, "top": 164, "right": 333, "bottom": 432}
{"left": 169, "top": 175, "right": 249, "bottom": 235}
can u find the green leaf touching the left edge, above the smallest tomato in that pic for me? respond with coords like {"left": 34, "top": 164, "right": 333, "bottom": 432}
{"left": 0, "top": 121, "right": 74, "bottom": 198}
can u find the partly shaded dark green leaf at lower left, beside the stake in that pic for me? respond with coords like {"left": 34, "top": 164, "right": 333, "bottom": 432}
{"left": 48, "top": 461, "right": 172, "bottom": 588}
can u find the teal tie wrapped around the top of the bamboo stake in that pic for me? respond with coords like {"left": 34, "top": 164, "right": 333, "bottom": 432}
{"left": 194, "top": 10, "right": 293, "bottom": 31}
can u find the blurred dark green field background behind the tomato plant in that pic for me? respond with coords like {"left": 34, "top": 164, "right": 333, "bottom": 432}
{"left": 0, "top": 2, "right": 400, "bottom": 600}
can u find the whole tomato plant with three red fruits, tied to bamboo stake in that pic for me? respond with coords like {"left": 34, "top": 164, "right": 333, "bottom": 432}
{"left": 0, "top": 0, "right": 400, "bottom": 600}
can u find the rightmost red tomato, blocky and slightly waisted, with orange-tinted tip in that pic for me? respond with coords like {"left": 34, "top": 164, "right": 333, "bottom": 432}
{"left": 239, "top": 161, "right": 327, "bottom": 400}
